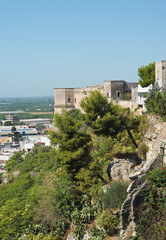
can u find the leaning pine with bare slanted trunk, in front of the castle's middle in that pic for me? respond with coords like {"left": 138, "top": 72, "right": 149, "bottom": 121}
{"left": 80, "top": 91, "right": 139, "bottom": 148}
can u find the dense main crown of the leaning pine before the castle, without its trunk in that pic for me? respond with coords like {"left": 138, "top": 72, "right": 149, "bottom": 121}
{"left": 80, "top": 91, "right": 121, "bottom": 136}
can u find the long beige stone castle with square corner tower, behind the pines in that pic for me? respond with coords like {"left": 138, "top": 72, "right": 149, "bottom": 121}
{"left": 54, "top": 80, "right": 138, "bottom": 113}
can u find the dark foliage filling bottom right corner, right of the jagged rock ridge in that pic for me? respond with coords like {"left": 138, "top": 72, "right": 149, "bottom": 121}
{"left": 136, "top": 167, "right": 166, "bottom": 240}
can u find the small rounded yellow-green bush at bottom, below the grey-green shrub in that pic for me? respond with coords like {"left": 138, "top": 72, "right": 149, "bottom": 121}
{"left": 97, "top": 209, "right": 119, "bottom": 235}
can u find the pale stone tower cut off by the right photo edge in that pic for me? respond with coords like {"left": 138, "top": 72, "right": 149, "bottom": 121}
{"left": 155, "top": 60, "right": 166, "bottom": 90}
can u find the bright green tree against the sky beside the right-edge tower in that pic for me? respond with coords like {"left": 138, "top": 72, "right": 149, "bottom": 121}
{"left": 138, "top": 62, "right": 155, "bottom": 87}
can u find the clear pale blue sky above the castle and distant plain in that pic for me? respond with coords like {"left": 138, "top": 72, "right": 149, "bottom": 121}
{"left": 0, "top": 0, "right": 166, "bottom": 97}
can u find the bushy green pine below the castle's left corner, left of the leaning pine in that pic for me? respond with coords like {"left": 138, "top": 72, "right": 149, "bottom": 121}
{"left": 50, "top": 111, "right": 91, "bottom": 179}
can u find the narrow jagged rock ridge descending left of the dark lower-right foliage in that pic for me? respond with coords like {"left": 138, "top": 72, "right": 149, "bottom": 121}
{"left": 120, "top": 155, "right": 162, "bottom": 240}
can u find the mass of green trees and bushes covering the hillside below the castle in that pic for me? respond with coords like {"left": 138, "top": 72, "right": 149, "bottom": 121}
{"left": 0, "top": 92, "right": 163, "bottom": 240}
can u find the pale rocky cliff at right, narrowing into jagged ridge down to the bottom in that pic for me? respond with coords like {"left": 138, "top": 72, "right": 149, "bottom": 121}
{"left": 120, "top": 116, "right": 166, "bottom": 240}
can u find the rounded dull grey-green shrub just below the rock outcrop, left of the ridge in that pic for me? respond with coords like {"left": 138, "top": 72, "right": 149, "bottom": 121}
{"left": 102, "top": 181, "right": 128, "bottom": 209}
